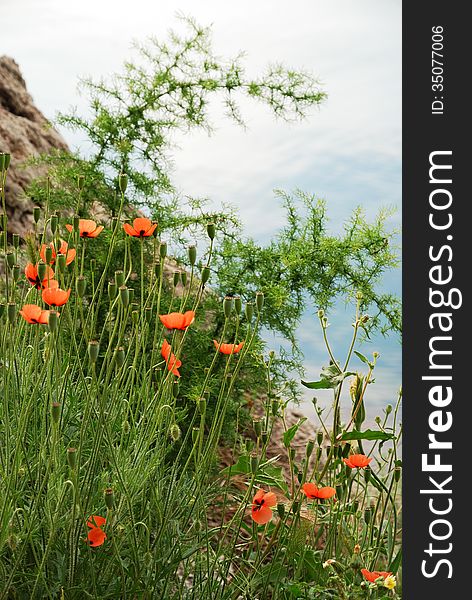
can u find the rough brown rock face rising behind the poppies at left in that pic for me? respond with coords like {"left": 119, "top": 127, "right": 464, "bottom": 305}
{"left": 0, "top": 56, "right": 68, "bottom": 235}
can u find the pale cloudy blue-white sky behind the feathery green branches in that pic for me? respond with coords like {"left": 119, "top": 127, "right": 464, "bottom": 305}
{"left": 0, "top": 0, "right": 401, "bottom": 420}
